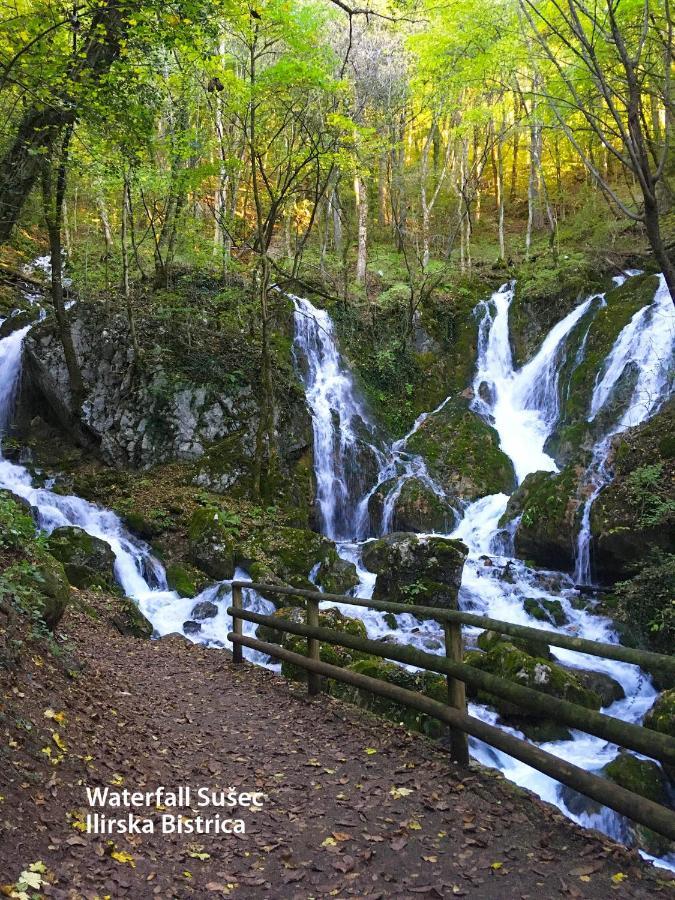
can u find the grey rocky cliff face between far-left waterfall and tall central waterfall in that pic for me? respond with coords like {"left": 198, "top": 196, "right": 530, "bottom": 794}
{"left": 21, "top": 304, "right": 311, "bottom": 491}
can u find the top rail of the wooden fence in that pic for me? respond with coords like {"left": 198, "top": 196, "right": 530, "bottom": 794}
{"left": 232, "top": 581, "right": 675, "bottom": 675}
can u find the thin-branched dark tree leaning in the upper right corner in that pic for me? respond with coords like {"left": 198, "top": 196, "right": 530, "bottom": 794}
{"left": 519, "top": 0, "right": 675, "bottom": 303}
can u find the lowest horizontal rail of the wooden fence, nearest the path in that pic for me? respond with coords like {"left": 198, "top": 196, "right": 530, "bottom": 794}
{"left": 228, "top": 632, "right": 675, "bottom": 840}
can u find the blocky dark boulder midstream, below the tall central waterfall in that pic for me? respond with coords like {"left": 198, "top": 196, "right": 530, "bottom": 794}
{"left": 363, "top": 532, "right": 468, "bottom": 609}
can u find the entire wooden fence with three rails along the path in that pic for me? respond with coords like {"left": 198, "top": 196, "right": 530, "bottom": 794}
{"left": 228, "top": 581, "right": 675, "bottom": 840}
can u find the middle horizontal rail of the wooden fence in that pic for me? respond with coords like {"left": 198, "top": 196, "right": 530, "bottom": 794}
{"left": 227, "top": 607, "right": 675, "bottom": 764}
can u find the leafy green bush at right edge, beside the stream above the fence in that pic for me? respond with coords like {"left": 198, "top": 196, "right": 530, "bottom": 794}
{"left": 614, "top": 550, "right": 675, "bottom": 653}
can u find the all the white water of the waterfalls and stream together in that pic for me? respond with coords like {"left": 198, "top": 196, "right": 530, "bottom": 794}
{"left": 0, "top": 273, "right": 675, "bottom": 868}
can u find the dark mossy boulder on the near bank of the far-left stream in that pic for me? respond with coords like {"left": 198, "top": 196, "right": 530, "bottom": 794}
{"left": 47, "top": 526, "right": 115, "bottom": 589}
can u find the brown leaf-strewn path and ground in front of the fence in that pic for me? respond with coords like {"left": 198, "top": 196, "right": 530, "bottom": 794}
{"left": 0, "top": 594, "right": 673, "bottom": 900}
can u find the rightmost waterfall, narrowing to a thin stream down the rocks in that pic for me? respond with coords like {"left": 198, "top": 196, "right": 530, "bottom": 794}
{"left": 574, "top": 275, "right": 675, "bottom": 584}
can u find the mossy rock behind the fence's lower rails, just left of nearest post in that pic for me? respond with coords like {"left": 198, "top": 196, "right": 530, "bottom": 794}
{"left": 328, "top": 656, "right": 448, "bottom": 738}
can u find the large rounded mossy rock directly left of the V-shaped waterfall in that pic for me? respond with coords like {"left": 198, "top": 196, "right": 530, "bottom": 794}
{"left": 407, "top": 396, "right": 515, "bottom": 501}
